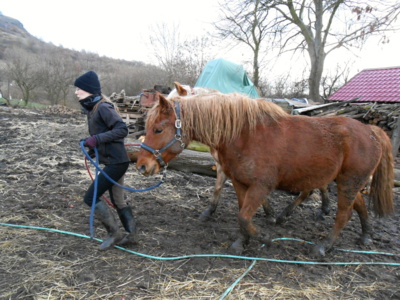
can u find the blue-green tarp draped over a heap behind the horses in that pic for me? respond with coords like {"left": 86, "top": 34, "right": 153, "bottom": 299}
{"left": 195, "top": 58, "right": 260, "bottom": 98}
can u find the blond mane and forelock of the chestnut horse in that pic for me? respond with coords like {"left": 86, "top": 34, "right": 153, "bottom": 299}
{"left": 146, "top": 93, "right": 289, "bottom": 148}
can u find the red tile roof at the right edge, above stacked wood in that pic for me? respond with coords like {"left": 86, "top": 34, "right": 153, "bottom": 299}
{"left": 328, "top": 67, "right": 400, "bottom": 102}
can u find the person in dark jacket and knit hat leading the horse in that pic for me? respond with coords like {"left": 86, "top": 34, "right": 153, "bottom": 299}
{"left": 74, "top": 71, "right": 136, "bottom": 250}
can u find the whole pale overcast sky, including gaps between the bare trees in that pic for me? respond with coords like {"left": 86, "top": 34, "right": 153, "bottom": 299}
{"left": 0, "top": 0, "right": 400, "bottom": 76}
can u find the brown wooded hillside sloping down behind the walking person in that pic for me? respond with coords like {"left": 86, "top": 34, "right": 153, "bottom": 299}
{"left": 0, "top": 12, "right": 168, "bottom": 107}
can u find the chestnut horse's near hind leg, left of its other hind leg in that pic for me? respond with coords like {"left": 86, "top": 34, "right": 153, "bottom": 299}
{"left": 313, "top": 182, "right": 361, "bottom": 256}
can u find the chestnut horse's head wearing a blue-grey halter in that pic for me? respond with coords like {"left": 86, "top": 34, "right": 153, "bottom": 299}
{"left": 136, "top": 94, "right": 188, "bottom": 176}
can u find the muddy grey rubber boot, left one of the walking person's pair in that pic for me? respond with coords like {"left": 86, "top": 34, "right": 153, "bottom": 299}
{"left": 94, "top": 201, "right": 123, "bottom": 250}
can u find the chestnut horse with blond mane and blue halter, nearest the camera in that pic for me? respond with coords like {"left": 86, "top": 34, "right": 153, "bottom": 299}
{"left": 136, "top": 93, "right": 394, "bottom": 255}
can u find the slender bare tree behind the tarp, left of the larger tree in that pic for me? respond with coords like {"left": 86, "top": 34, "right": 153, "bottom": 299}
{"left": 214, "top": 0, "right": 272, "bottom": 88}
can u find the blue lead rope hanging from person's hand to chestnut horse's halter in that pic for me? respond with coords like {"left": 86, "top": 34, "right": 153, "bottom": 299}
{"left": 80, "top": 141, "right": 167, "bottom": 238}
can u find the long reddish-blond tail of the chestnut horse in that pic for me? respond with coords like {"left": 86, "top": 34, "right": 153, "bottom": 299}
{"left": 369, "top": 126, "right": 394, "bottom": 217}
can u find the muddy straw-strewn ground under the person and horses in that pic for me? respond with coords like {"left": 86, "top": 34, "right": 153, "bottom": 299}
{"left": 0, "top": 107, "right": 400, "bottom": 299}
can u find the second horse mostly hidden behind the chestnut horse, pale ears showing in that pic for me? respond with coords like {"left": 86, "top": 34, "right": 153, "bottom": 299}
{"left": 167, "top": 81, "right": 330, "bottom": 224}
